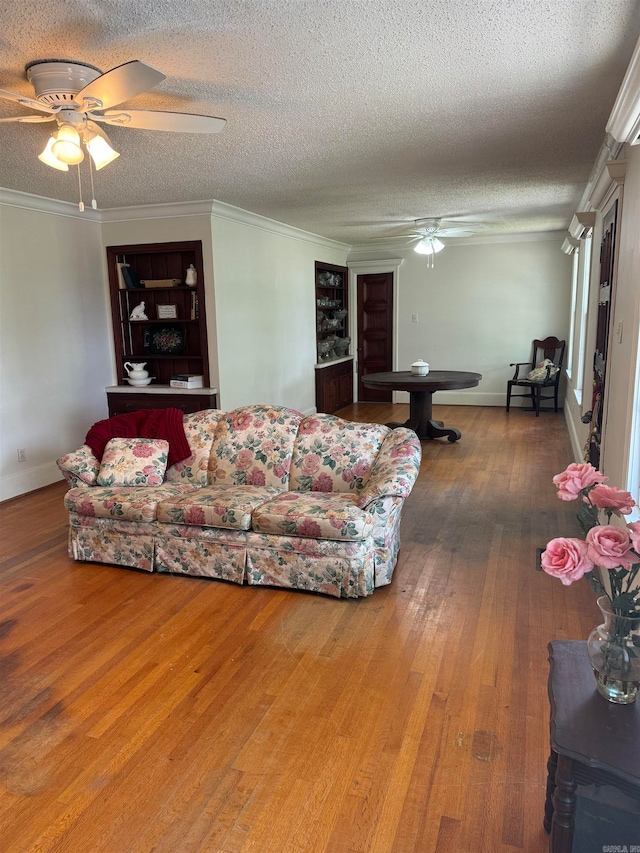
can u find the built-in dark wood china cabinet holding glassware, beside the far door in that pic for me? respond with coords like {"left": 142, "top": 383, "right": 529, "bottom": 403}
{"left": 315, "top": 261, "right": 353, "bottom": 414}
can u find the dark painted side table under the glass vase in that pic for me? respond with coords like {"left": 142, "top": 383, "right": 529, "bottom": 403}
{"left": 544, "top": 640, "right": 640, "bottom": 853}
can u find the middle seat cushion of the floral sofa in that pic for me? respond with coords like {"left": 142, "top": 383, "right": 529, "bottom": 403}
{"left": 158, "top": 486, "right": 281, "bottom": 530}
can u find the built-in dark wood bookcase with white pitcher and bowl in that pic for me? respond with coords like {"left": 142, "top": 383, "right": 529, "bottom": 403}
{"left": 107, "top": 240, "right": 215, "bottom": 414}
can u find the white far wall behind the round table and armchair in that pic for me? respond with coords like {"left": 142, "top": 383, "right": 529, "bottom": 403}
{"left": 349, "top": 235, "right": 571, "bottom": 406}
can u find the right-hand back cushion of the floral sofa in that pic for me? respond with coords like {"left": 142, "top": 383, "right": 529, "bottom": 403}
{"left": 289, "top": 414, "right": 390, "bottom": 492}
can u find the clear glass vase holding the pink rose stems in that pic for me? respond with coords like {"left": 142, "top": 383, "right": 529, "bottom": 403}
{"left": 587, "top": 595, "right": 640, "bottom": 705}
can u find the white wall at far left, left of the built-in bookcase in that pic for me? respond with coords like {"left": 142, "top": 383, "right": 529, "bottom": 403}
{"left": 0, "top": 190, "right": 113, "bottom": 500}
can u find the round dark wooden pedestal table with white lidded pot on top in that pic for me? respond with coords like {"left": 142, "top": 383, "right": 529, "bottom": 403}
{"left": 362, "top": 370, "right": 482, "bottom": 441}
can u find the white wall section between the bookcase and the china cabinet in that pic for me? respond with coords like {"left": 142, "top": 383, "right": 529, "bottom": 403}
{"left": 212, "top": 216, "right": 347, "bottom": 413}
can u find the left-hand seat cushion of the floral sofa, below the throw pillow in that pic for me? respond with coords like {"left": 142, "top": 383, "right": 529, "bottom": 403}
{"left": 64, "top": 483, "right": 195, "bottom": 521}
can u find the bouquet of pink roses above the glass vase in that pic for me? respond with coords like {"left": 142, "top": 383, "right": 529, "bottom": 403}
{"left": 540, "top": 462, "right": 640, "bottom": 617}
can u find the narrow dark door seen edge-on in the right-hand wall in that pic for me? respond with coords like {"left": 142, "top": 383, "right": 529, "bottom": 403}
{"left": 587, "top": 201, "right": 618, "bottom": 468}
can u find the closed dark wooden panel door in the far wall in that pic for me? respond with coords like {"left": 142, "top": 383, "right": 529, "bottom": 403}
{"left": 357, "top": 272, "right": 393, "bottom": 403}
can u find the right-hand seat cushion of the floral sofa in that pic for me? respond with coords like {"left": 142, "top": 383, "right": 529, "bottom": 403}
{"left": 252, "top": 492, "right": 373, "bottom": 540}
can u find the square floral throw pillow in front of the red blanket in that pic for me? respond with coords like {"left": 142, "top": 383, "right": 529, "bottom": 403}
{"left": 97, "top": 438, "right": 169, "bottom": 486}
